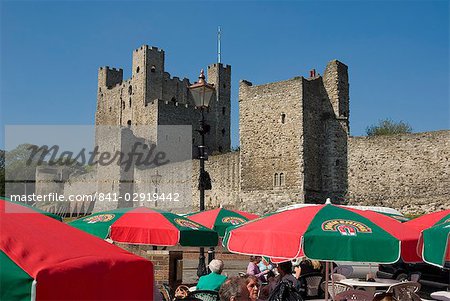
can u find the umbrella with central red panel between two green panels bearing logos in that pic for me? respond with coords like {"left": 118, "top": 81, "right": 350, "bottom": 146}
{"left": 70, "top": 207, "right": 218, "bottom": 247}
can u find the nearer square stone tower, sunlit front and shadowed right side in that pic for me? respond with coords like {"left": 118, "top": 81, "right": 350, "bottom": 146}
{"left": 239, "top": 61, "right": 349, "bottom": 208}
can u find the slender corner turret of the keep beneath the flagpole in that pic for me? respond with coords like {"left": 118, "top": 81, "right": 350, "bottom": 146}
{"left": 207, "top": 63, "right": 231, "bottom": 153}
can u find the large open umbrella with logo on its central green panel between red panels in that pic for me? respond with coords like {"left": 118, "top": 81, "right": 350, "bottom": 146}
{"left": 223, "top": 205, "right": 421, "bottom": 263}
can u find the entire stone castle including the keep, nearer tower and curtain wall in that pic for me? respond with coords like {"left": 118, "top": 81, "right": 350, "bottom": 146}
{"left": 37, "top": 46, "right": 450, "bottom": 213}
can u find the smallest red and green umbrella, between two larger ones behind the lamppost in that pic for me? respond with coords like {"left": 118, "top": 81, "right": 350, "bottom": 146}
{"left": 186, "top": 208, "right": 259, "bottom": 237}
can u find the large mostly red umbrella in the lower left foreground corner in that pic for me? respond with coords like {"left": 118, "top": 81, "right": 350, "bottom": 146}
{"left": 0, "top": 198, "right": 153, "bottom": 300}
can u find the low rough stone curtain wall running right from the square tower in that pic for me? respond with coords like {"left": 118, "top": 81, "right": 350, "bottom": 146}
{"left": 348, "top": 131, "right": 450, "bottom": 213}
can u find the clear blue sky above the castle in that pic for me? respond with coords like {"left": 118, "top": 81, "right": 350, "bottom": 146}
{"left": 0, "top": 0, "right": 450, "bottom": 147}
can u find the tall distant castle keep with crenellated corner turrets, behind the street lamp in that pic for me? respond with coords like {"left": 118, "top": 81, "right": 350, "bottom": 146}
{"left": 92, "top": 45, "right": 231, "bottom": 211}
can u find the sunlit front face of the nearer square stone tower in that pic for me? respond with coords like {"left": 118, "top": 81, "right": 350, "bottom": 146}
{"left": 239, "top": 78, "right": 303, "bottom": 192}
